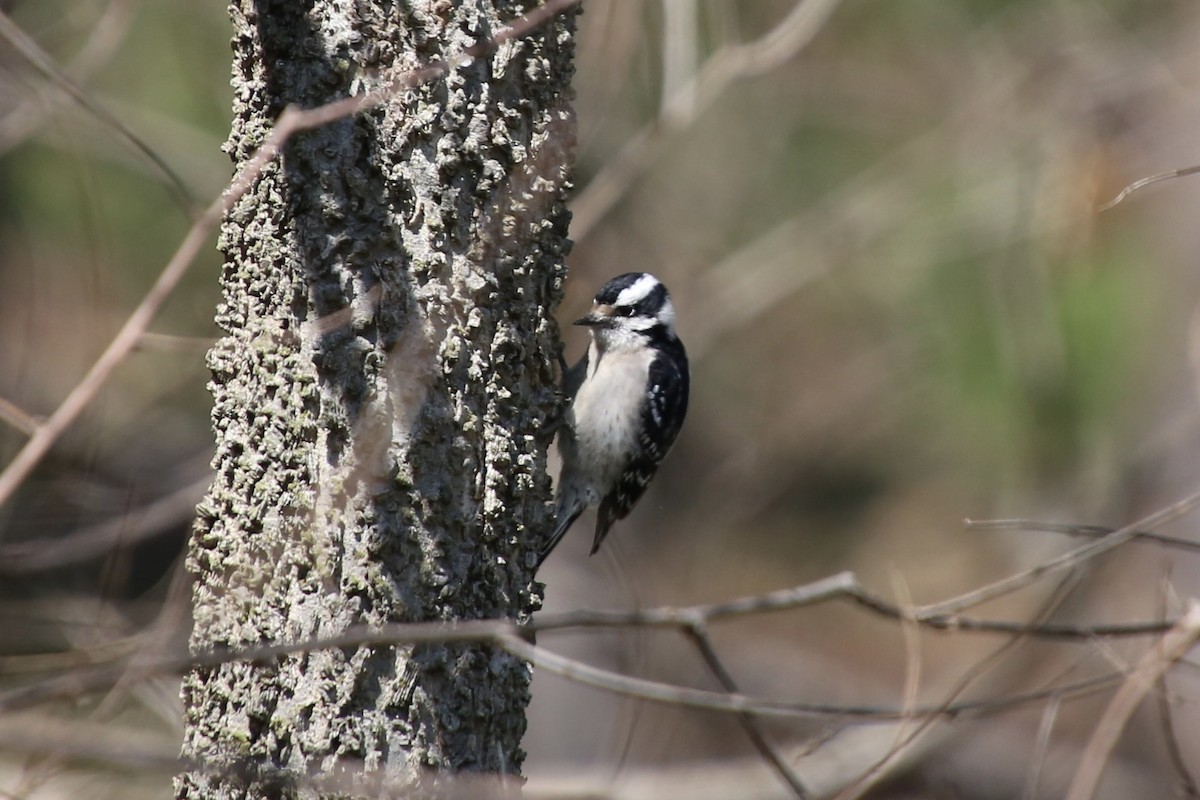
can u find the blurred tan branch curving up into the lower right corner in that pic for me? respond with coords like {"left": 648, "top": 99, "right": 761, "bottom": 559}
{"left": 1067, "top": 601, "right": 1200, "bottom": 800}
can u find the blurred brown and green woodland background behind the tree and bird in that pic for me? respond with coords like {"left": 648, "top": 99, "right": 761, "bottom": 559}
{"left": 0, "top": 0, "right": 1200, "bottom": 798}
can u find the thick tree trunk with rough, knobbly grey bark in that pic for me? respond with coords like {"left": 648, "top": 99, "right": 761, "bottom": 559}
{"left": 176, "top": 0, "right": 574, "bottom": 799}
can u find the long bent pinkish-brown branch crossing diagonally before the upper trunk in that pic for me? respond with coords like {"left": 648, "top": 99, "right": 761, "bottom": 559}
{"left": 0, "top": 0, "right": 580, "bottom": 520}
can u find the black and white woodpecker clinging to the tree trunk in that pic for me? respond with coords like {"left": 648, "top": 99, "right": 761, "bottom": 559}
{"left": 538, "top": 272, "right": 690, "bottom": 567}
